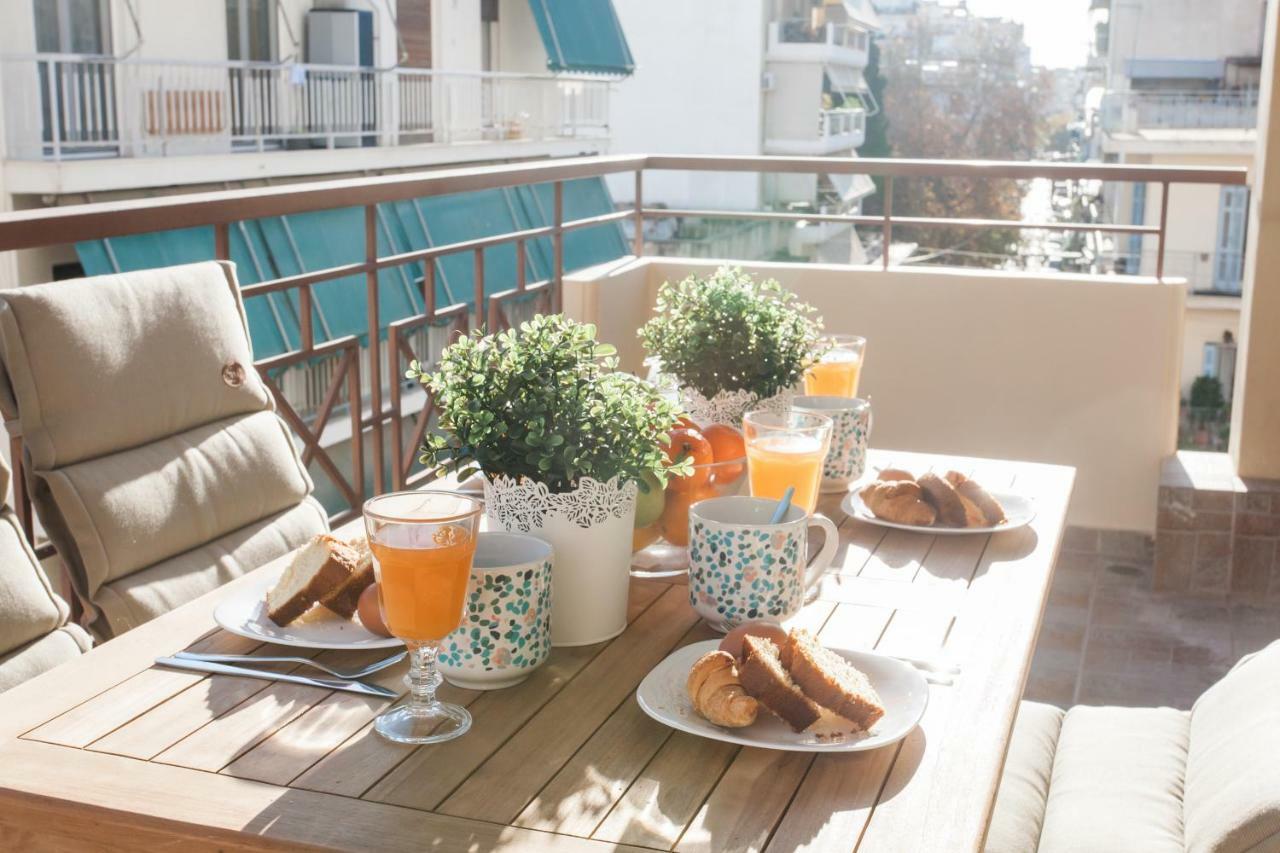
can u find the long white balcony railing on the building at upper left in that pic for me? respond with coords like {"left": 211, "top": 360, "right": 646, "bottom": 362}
{"left": 0, "top": 54, "right": 609, "bottom": 160}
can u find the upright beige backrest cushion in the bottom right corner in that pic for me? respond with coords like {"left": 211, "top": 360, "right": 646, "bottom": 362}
{"left": 1185, "top": 642, "right": 1280, "bottom": 853}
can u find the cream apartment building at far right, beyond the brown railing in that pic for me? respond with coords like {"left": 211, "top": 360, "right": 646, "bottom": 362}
{"left": 1091, "top": 0, "right": 1266, "bottom": 397}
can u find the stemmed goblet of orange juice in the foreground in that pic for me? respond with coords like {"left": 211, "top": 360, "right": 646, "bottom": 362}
{"left": 365, "top": 491, "right": 481, "bottom": 743}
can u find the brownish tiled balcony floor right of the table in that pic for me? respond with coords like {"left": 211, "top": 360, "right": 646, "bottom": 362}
{"left": 1025, "top": 529, "right": 1280, "bottom": 708}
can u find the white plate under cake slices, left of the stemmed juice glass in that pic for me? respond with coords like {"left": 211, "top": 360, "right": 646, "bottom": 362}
{"left": 214, "top": 578, "right": 403, "bottom": 648}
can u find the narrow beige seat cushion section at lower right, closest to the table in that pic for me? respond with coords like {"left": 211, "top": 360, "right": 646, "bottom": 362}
{"left": 986, "top": 702, "right": 1065, "bottom": 853}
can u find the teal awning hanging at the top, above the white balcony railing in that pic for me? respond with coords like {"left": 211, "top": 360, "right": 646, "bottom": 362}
{"left": 529, "top": 0, "right": 636, "bottom": 76}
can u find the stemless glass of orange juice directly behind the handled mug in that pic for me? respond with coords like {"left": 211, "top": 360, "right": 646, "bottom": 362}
{"left": 742, "top": 411, "right": 832, "bottom": 514}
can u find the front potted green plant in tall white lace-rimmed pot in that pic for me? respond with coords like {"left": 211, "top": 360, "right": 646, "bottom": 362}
{"left": 407, "top": 315, "right": 689, "bottom": 646}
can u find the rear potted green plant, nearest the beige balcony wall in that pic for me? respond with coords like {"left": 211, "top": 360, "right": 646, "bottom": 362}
{"left": 639, "top": 266, "right": 822, "bottom": 424}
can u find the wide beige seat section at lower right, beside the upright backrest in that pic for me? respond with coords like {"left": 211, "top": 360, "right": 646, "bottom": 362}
{"left": 1039, "top": 706, "right": 1189, "bottom": 853}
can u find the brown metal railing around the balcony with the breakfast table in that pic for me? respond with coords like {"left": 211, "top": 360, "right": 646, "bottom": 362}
{"left": 0, "top": 155, "right": 1247, "bottom": 534}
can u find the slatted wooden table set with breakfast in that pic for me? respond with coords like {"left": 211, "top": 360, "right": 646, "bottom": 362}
{"left": 0, "top": 452, "right": 1074, "bottom": 852}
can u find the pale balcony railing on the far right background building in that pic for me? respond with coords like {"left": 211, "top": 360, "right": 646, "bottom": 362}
{"left": 1102, "top": 88, "right": 1258, "bottom": 133}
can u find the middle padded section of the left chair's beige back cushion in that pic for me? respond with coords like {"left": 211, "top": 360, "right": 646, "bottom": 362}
{"left": 37, "top": 411, "right": 311, "bottom": 598}
